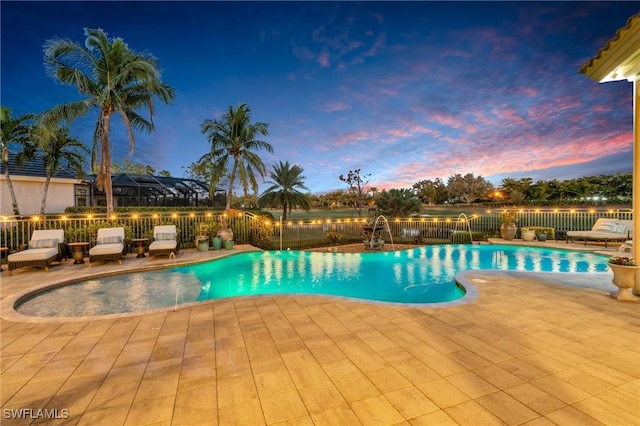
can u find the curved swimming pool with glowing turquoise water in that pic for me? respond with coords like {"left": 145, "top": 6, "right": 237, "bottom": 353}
{"left": 16, "top": 244, "right": 607, "bottom": 317}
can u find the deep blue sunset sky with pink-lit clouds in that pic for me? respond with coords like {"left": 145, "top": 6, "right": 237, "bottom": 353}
{"left": 0, "top": 0, "right": 639, "bottom": 193}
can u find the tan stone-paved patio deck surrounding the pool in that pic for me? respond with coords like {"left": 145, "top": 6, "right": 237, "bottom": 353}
{"left": 0, "top": 240, "right": 640, "bottom": 425}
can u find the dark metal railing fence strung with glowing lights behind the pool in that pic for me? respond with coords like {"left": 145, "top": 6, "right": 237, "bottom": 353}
{"left": 0, "top": 209, "right": 633, "bottom": 252}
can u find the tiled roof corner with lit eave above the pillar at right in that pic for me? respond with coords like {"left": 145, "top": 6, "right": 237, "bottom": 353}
{"left": 579, "top": 13, "right": 640, "bottom": 83}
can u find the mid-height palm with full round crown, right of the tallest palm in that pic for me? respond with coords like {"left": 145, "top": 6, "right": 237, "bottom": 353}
{"left": 198, "top": 104, "right": 273, "bottom": 209}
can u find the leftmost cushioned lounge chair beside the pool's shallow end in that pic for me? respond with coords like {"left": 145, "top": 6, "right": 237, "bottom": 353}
{"left": 7, "top": 229, "right": 67, "bottom": 275}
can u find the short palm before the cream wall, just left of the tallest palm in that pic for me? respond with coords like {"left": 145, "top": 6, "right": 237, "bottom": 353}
{"left": 32, "top": 124, "right": 89, "bottom": 214}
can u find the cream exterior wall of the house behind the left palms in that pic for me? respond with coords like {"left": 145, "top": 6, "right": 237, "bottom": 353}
{"left": 0, "top": 175, "right": 80, "bottom": 216}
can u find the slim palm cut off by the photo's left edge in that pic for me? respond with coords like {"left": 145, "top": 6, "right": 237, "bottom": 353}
{"left": 0, "top": 106, "right": 34, "bottom": 216}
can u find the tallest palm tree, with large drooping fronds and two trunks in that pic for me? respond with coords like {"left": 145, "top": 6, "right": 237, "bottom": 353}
{"left": 44, "top": 28, "right": 175, "bottom": 213}
